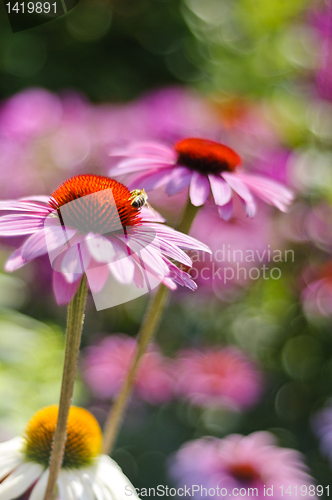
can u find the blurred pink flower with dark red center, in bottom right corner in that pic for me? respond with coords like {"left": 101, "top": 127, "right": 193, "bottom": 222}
{"left": 170, "top": 432, "right": 317, "bottom": 500}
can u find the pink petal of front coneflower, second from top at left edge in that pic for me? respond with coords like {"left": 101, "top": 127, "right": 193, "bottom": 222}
{"left": 0, "top": 214, "right": 45, "bottom": 236}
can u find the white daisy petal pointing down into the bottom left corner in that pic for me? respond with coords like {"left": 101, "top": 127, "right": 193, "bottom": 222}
{"left": 0, "top": 462, "right": 43, "bottom": 500}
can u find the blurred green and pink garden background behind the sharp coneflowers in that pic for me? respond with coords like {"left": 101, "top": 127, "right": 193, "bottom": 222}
{"left": 0, "top": 0, "right": 332, "bottom": 496}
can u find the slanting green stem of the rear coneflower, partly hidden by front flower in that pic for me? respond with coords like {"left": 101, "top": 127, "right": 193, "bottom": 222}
{"left": 104, "top": 199, "right": 198, "bottom": 454}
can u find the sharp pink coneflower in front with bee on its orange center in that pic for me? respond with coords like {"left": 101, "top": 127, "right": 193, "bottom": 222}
{"left": 0, "top": 174, "right": 209, "bottom": 304}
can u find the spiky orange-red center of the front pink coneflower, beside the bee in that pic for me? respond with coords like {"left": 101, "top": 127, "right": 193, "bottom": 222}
{"left": 49, "top": 174, "right": 141, "bottom": 234}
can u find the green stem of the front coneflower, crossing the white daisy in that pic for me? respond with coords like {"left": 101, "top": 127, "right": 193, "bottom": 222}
{"left": 44, "top": 274, "right": 88, "bottom": 500}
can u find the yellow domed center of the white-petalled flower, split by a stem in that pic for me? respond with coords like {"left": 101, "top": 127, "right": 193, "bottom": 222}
{"left": 24, "top": 405, "right": 102, "bottom": 468}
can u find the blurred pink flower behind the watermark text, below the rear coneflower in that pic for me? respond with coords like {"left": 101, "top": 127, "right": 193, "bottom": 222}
{"left": 190, "top": 200, "right": 284, "bottom": 300}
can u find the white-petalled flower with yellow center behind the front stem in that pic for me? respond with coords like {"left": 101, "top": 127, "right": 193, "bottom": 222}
{"left": 0, "top": 405, "right": 138, "bottom": 500}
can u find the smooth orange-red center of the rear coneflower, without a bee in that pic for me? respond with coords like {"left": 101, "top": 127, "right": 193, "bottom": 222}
{"left": 174, "top": 138, "right": 241, "bottom": 175}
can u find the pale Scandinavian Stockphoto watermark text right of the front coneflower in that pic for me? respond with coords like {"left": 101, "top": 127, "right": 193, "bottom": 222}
{"left": 179, "top": 244, "right": 295, "bottom": 285}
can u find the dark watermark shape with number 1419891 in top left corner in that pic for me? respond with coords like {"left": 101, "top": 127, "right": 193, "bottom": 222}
{"left": 3, "top": 0, "right": 79, "bottom": 33}
